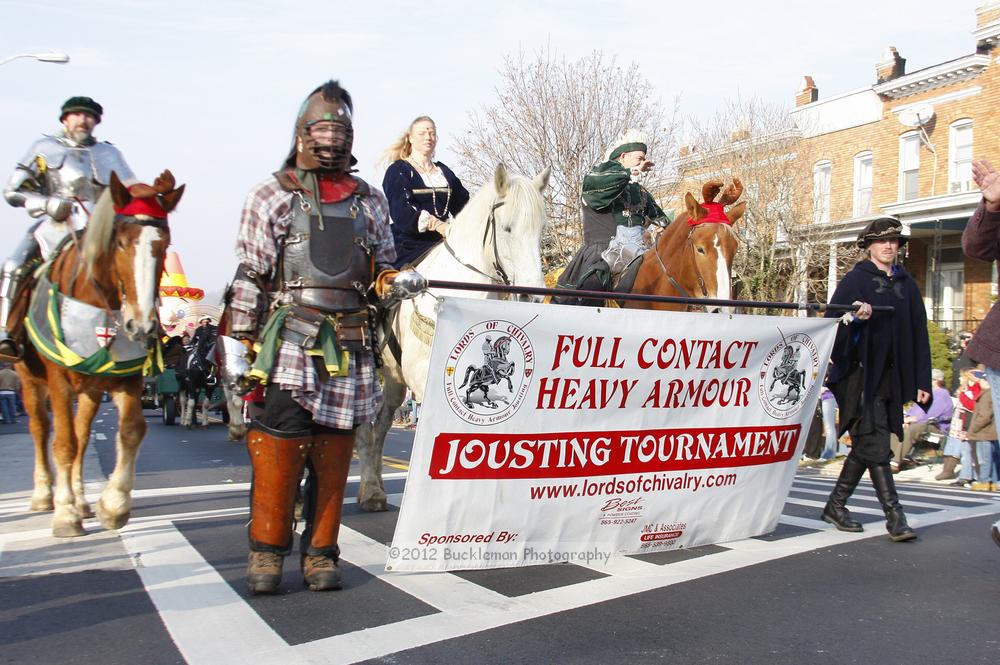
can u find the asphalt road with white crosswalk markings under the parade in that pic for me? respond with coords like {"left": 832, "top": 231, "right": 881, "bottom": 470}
{"left": 0, "top": 405, "right": 1000, "bottom": 665}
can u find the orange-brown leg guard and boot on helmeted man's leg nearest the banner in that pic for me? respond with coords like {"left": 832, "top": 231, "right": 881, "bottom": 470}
{"left": 301, "top": 434, "right": 354, "bottom": 591}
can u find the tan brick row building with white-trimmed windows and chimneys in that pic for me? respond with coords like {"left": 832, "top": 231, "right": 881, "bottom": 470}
{"left": 791, "top": 0, "right": 1000, "bottom": 332}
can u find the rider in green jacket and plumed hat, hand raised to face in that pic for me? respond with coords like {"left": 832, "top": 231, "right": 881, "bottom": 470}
{"left": 556, "top": 130, "right": 670, "bottom": 304}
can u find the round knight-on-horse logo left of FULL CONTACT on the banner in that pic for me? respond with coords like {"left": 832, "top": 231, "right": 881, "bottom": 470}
{"left": 444, "top": 320, "right": 535, "bottom": 425}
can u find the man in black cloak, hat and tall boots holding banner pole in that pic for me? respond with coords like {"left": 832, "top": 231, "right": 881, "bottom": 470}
{"left": 822, "top": 217, "right": 931, "bottom": 542}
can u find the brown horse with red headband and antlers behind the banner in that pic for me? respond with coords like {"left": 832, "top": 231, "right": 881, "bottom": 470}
{"left": 624, "top": 178, "right": 746, "bottom": 311}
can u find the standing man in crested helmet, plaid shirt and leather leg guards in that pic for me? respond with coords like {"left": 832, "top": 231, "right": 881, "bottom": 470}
{"left": 219, "top": 81, "right": 426, "bottom": 593}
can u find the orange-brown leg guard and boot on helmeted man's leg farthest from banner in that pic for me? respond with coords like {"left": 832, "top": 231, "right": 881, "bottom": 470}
{"left": 247, "top": 422, "right": 312, "bottom": 593}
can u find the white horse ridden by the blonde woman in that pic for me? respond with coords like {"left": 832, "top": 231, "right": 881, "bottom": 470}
{"left": 355, "top": 164, "right": 551, "bottom": 512}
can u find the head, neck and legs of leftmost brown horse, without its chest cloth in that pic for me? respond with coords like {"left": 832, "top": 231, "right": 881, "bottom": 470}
{"left": 17, "top": 171, "right": 184, "bottom": 537}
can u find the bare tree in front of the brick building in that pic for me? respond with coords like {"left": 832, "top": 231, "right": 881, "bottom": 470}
{"left": 677, "top": 99, "right": 850, "bottom": 302}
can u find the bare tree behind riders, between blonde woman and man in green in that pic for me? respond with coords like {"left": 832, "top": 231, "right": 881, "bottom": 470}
{"left": 457, "top": 49, "right": 676, "bottom": 269}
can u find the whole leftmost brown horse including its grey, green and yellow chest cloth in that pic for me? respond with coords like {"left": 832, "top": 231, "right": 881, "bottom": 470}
{"left": 16, "top": 171, "right": 184, "bottom": 537}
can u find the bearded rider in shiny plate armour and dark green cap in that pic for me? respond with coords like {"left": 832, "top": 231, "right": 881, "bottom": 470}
{"left": 0, "top": 97, "right": 135, "bottom": 360}
